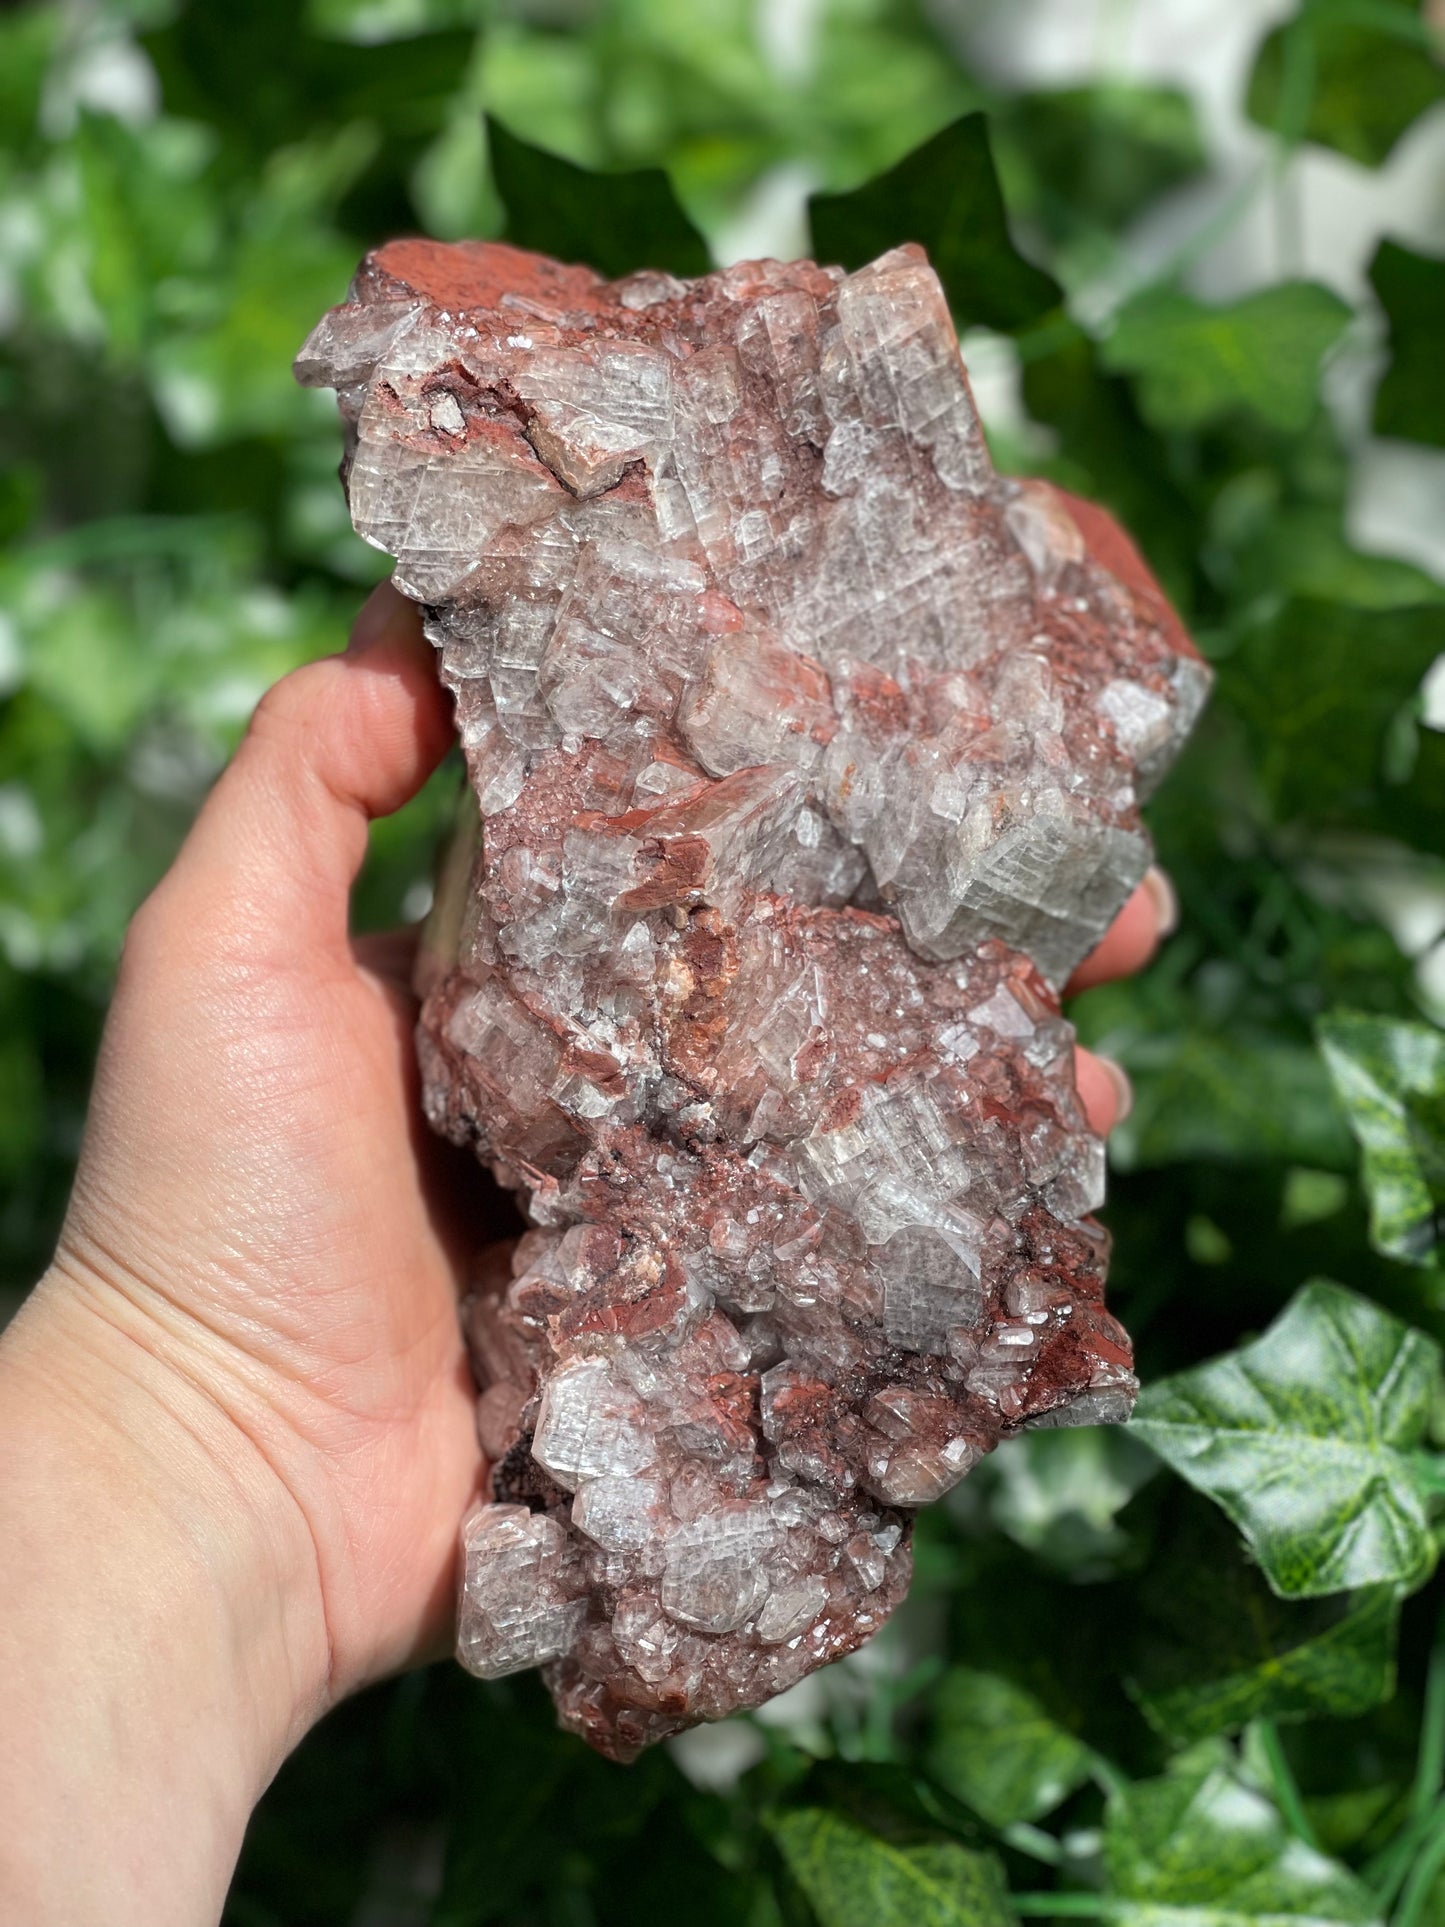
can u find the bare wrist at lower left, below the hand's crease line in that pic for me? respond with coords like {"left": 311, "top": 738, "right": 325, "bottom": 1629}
{"left": 0, "top": 1270, "right": 329, "bottom": 1927}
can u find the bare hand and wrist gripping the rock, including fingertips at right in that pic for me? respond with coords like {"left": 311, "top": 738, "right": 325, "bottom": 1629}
{"left": 0, "top": 586, "right": 1171, "bottom": 1927}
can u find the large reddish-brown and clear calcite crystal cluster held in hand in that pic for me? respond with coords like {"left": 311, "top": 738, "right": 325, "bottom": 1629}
{"left": 297, "top": 241, "right": 1208, "bottom": 1759}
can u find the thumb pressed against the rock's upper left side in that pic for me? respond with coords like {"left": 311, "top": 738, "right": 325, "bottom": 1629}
{"left": 158, "top": 582, "right": 453, "bottom": 960}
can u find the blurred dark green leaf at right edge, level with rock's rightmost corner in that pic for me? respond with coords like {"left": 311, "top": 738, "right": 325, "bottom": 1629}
{"left": 1218, "top": 597, "right": 1445, "bottom": 823}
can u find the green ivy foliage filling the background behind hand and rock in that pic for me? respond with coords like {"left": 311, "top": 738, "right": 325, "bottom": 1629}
{"left": 0, "top": 0, "right": 1445, "bottom": 1927}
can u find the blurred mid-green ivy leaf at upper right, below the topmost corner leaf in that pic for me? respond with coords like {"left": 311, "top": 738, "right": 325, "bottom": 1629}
{"left": 1100, "top": 281, "right": 1351, "bottom": 434}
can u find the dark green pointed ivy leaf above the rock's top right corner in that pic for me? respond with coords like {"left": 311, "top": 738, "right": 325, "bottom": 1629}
{"left": 807, "top": 114, "right": 1064, "bottom": 330}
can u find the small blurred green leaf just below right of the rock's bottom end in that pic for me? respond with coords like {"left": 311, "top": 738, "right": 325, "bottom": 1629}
{"left": 927, "top": 1667, "right": 1090, "bottom": 1827}
